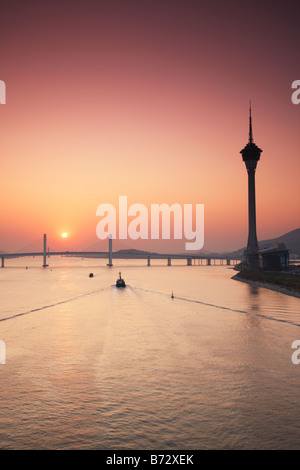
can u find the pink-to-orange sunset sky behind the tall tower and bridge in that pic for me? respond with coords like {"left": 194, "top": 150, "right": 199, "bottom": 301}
{"left": 0, "top": 0, "right": 300, "bottom": 251}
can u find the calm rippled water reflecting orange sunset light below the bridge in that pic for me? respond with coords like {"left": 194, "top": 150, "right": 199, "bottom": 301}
{"left": 0, "top": 258, "right": 300, "bottom": 450}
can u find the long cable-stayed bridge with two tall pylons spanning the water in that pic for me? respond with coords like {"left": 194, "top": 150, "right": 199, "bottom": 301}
{"left": 0, "top": 234, "right": 244, "bottom": 268}
